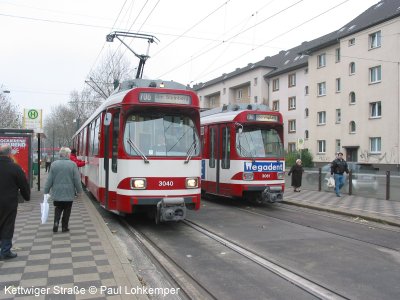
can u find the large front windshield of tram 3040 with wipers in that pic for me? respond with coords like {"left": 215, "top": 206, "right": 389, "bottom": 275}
{"left": 124, "top": 113, "right": 200, "bottom": 157}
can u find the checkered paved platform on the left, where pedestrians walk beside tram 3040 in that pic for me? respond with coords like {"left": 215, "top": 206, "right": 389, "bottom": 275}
{"left": 0, "top": 170, "right": 148, "bottom": 300}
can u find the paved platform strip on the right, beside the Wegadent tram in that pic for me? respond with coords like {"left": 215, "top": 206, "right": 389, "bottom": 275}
{"left": 282, "top": 187, "right": 400, "bottom": 226}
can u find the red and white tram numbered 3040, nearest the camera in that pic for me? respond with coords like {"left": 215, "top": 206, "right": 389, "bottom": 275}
{"left": 73, "top": 79, "right": 201, "bottom": 222}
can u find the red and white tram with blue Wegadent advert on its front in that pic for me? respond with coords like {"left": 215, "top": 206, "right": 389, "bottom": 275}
{"left": 201, "top": 105, "right": 285, "bottom": 203}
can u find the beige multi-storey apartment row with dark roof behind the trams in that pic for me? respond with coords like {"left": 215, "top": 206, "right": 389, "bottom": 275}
{"left": 194, "top": 0, "right": 400, "bottom": 169}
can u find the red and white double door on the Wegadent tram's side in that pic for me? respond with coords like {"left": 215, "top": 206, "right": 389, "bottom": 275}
{"left": 207, "top": 124, "right": 231, "bottom": 195}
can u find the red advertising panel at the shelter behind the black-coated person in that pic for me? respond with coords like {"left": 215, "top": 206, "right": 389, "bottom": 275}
{"left": 0, "top": 136, "right": 29, "bottom": 179}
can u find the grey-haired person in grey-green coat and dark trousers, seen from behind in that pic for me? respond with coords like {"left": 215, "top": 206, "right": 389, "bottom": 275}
{"left": 44, "top": 147, "right": 82, "bottom": 232}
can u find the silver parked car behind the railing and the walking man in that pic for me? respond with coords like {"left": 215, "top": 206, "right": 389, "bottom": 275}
{"left": 321, "top": 162, "right": 378, "bottom": 193}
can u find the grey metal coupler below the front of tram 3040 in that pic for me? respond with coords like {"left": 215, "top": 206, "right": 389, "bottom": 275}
{"left": 157, "top": 198, "right": 186, "bottom": 222}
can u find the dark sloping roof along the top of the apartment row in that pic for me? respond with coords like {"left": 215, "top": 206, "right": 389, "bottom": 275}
{"left": 193, "top": 0, "right": 400, "bottom": 91}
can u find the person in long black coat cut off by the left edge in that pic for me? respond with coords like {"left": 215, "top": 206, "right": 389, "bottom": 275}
{"left": 0, "top": 145, "right": 31, "bottom": 260}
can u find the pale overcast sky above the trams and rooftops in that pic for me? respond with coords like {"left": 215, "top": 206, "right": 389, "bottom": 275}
{"left": 0, "top": 0, "right": 379, "bottom": 118}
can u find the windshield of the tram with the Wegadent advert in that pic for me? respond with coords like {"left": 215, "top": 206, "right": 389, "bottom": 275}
{"left": 236, "top": 127, "right": 283, "bottom": 157}
